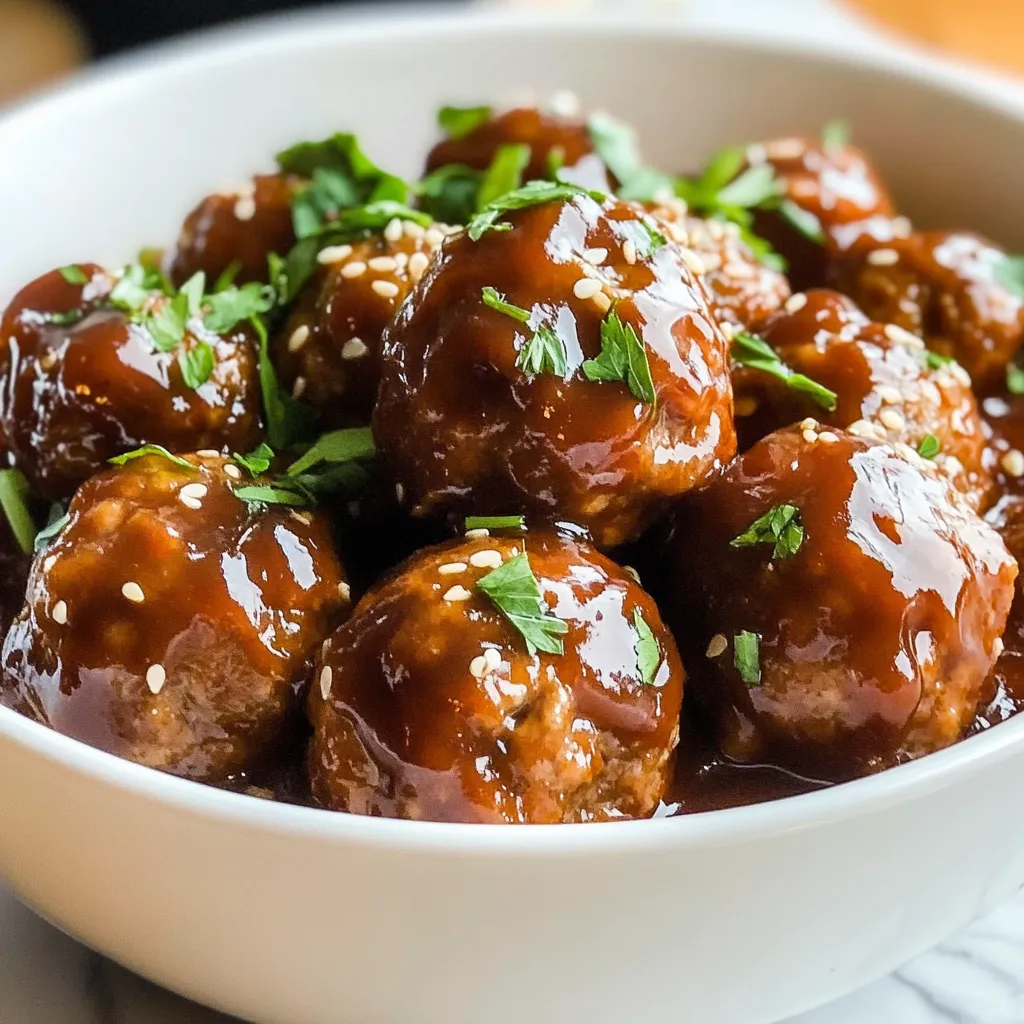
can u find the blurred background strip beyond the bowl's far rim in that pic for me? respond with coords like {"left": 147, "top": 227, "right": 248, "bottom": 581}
{"left": 0, "top": 0, "right": 1024, "bottom": 104}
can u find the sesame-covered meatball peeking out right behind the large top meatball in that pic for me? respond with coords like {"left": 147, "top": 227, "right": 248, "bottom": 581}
{"left": 650, "top": 200, "right": 790, "bottom": 330}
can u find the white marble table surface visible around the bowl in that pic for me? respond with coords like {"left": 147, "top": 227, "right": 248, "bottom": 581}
{"left": 0, "top": 0, "right": 1024, "bottom": 1024}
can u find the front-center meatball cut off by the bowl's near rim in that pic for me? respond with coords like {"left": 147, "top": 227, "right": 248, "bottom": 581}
{"left": 309, "top": 530, "right": 684, "bottom": 823}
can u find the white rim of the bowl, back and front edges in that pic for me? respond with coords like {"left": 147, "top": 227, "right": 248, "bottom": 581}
{"left": 0, "top": 3, "right": 1024, "bottom": 857}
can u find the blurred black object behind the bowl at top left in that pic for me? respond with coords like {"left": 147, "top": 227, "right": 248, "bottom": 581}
{"left": 62, "top": 0, "right": 403, "bottom": 56}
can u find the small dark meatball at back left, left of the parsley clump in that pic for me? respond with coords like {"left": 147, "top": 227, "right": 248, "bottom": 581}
{"left": 166, "top": 174, "right": 301, "bottom": 286}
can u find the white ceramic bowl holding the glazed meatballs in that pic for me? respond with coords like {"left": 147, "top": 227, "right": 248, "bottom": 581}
{"left": 0, "top": 13, "right": 1024, "bottom": 1024}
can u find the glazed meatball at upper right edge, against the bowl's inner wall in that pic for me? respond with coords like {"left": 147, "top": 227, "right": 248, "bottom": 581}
{"left": 835, "top": 231, "right": 1024, "bottom": 391}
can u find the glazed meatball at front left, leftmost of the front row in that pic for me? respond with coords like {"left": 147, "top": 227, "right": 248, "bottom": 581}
{"left": 2, "top": 453, "right": 348, "bottom": 781}
